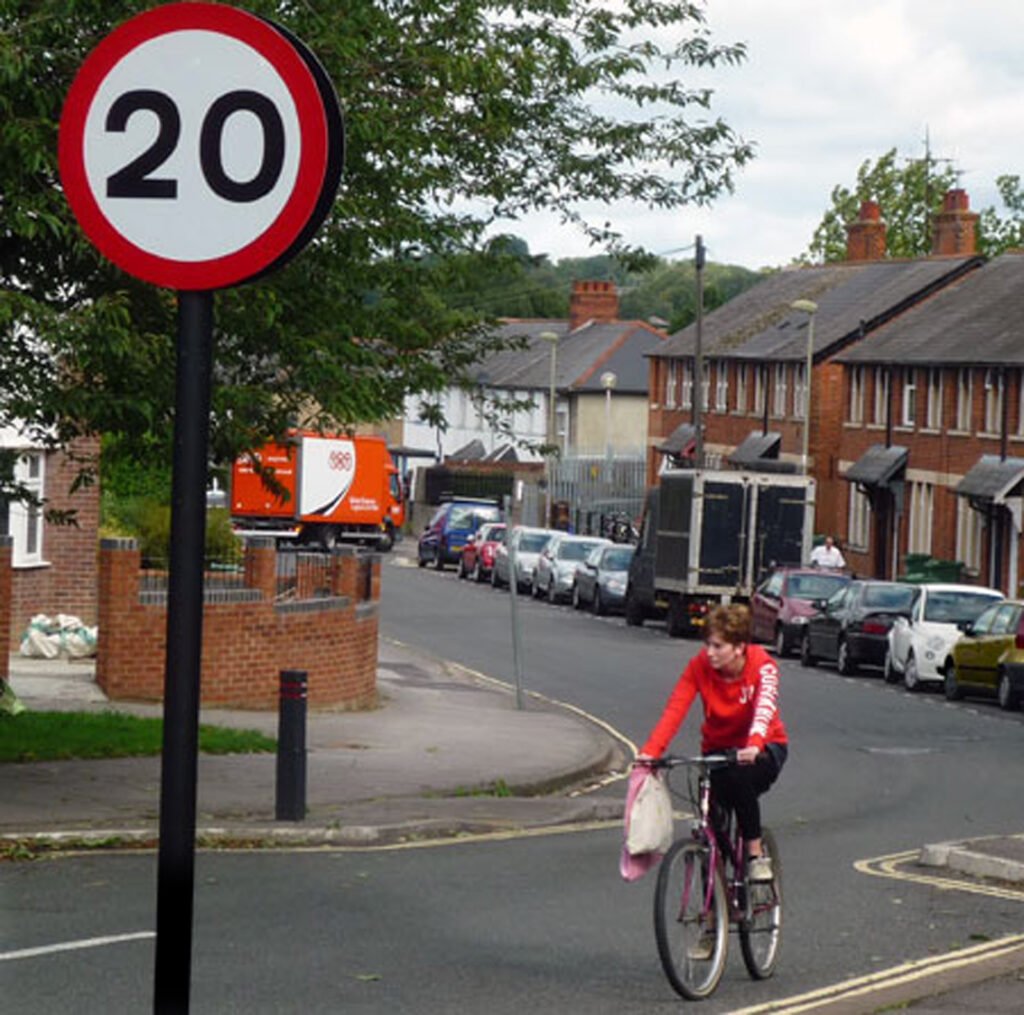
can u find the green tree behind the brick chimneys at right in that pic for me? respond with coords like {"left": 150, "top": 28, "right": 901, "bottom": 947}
{"left": 798, "top": 149, "right": 1024, "bottom": 263}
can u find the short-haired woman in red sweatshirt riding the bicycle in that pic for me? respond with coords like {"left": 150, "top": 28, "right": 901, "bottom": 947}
{"left": 637, "top": 605, "right": 788, "bottom": 881}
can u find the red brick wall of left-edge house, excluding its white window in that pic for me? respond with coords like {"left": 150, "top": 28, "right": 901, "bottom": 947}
{"left": 8, "top": 439, "right": 99, "bottom": 650}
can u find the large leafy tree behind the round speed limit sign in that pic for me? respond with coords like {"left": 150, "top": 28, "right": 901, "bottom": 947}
{"left": 0, "top": 0, "right": 752, "bottom": 499}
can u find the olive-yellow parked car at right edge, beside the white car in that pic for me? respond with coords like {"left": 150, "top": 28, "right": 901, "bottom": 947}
{"left": 943, "top": 599, "right": 1024, "bottom": 709}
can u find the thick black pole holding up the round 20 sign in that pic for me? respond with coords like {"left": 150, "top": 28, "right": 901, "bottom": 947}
{"left": 153, "top": 292, "right": 213, "bottom": 1015}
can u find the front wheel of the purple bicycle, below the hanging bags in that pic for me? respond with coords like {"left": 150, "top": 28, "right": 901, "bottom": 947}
{"left": 654, "top": 839, "right": 729, "bottom": 1001}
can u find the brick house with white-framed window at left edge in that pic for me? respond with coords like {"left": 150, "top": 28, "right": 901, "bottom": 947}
{"left": 0, "top": 429, "right": 99, "bottom": 651}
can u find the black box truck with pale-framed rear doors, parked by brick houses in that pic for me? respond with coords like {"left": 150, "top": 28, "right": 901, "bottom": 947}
{"left": 626, "top": 469, "right": 814, "bottom": 638}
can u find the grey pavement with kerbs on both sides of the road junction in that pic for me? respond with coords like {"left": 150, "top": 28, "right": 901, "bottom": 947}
{"left": 0, "top": 581, "right": 1024, "bottom": 1015}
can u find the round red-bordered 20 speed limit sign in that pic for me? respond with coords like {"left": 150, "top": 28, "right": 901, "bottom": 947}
{"left": 59, "top": 3, "right": 343, "bottom": 290}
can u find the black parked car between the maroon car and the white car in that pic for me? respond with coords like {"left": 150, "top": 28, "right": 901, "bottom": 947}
{"left": 800, "top": 580, "right": 915, "bottom": 676}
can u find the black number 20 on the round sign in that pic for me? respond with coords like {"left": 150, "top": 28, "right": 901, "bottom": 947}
{"left": 105, "top": 88, "right": 285, "bottom": 203}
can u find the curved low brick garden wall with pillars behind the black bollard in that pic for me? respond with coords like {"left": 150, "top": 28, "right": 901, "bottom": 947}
{"left": 96, "top": 540, "right": 380, "bottom": 709}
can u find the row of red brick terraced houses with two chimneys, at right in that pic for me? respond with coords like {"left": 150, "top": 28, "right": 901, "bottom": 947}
{"left": 648, "top": 191, "right": 1024, "bottom": 593}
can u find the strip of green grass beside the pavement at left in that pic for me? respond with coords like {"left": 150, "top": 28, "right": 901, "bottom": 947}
{"left": 0, "top": 712, "right": 278, "bottom": 762}
